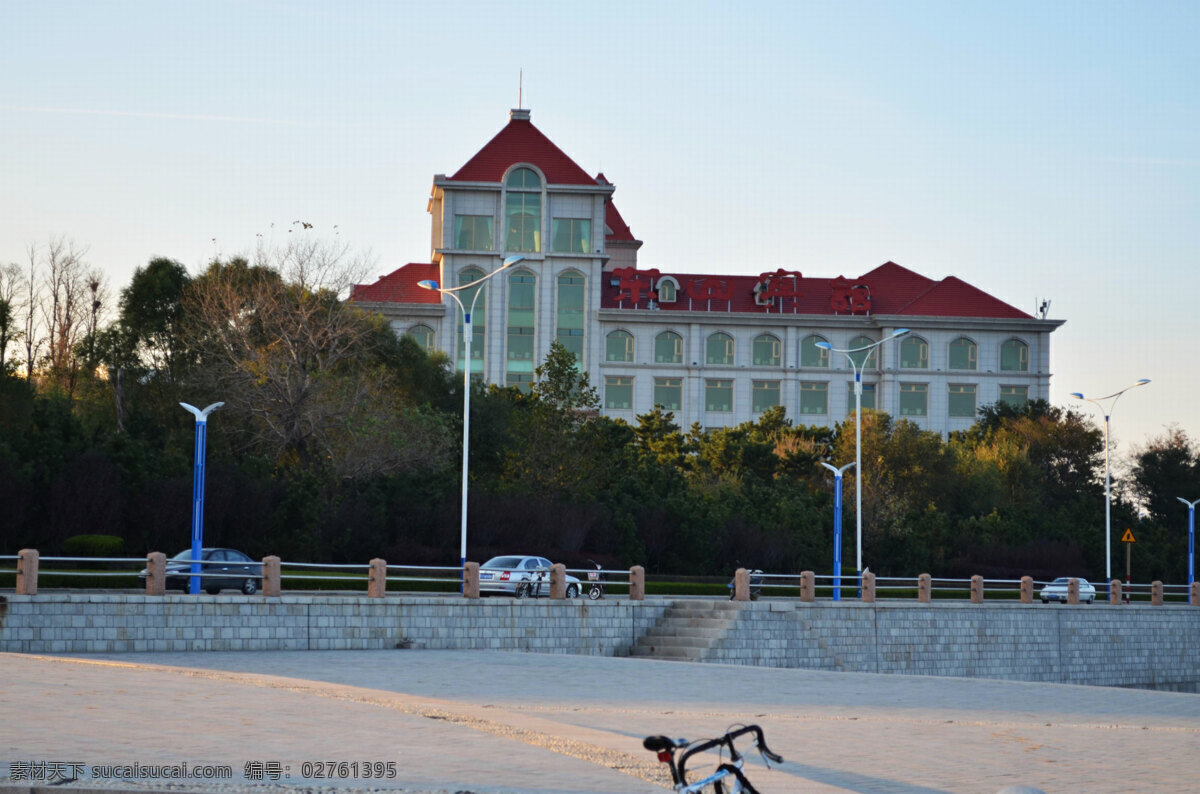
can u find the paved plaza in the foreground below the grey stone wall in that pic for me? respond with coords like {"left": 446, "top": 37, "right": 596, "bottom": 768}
{"left": 0, "top": 650, "right": 1200, "bottom": 794}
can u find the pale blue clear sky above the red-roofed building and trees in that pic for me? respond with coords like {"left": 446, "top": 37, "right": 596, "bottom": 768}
{"left": 0, "top": 0, "right": 1200, "bottom": 452}
